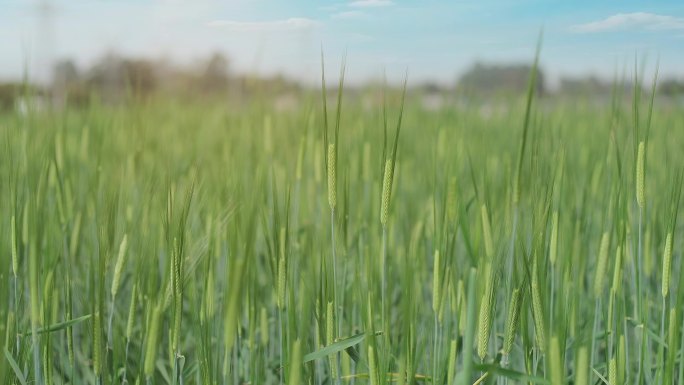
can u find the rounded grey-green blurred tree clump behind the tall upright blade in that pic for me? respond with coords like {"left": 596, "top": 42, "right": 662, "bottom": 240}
{"left": 458, "top": 63, "right": 545, "bottom": 94}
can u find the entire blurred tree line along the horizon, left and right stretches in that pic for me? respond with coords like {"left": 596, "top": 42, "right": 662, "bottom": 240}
{"left": 0, "top": 53, "right": 684, "bottom": 109}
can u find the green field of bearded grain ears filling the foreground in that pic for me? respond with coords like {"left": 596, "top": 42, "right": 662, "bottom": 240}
{"left": 0, "top": 63, "right": 684, "bottom": 385}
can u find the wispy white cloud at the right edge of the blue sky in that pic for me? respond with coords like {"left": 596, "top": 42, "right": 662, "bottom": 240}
{"left": 571, "top": 12, "right": 684, "bottom": 33}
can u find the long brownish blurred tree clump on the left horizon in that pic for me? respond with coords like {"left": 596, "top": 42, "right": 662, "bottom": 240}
{"left": 0, "top": 53, "right": 300, "bottom": 109}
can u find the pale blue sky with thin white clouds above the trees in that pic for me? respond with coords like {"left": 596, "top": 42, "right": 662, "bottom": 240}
{"left": 0, "top": 0, "right": 684, "bottom": 84}
